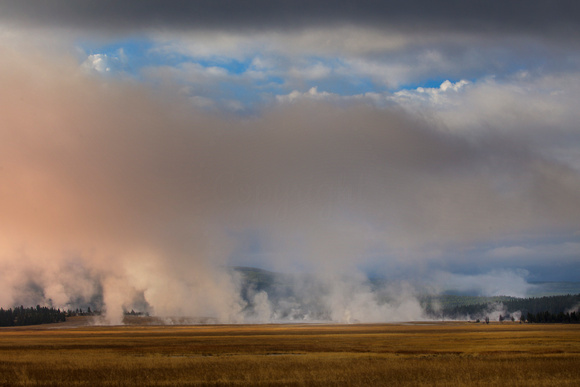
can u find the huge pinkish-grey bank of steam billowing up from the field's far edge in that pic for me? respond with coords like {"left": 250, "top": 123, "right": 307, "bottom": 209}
{"left": 0, "top": 45, "right": 580, "bottom": 323}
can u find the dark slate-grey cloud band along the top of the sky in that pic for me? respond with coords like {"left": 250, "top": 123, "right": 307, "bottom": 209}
{"left": 0, "top": 0, "right": 580, "bottom": 39}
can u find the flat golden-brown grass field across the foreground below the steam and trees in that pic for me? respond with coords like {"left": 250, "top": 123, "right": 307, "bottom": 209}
{"left": 0, "top": 323, "right": 580, "bottom": 386}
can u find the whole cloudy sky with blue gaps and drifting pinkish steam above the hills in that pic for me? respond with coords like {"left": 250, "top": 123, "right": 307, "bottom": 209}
{"left": 0, "top": 0, "right": 580, "bottom": 321}
